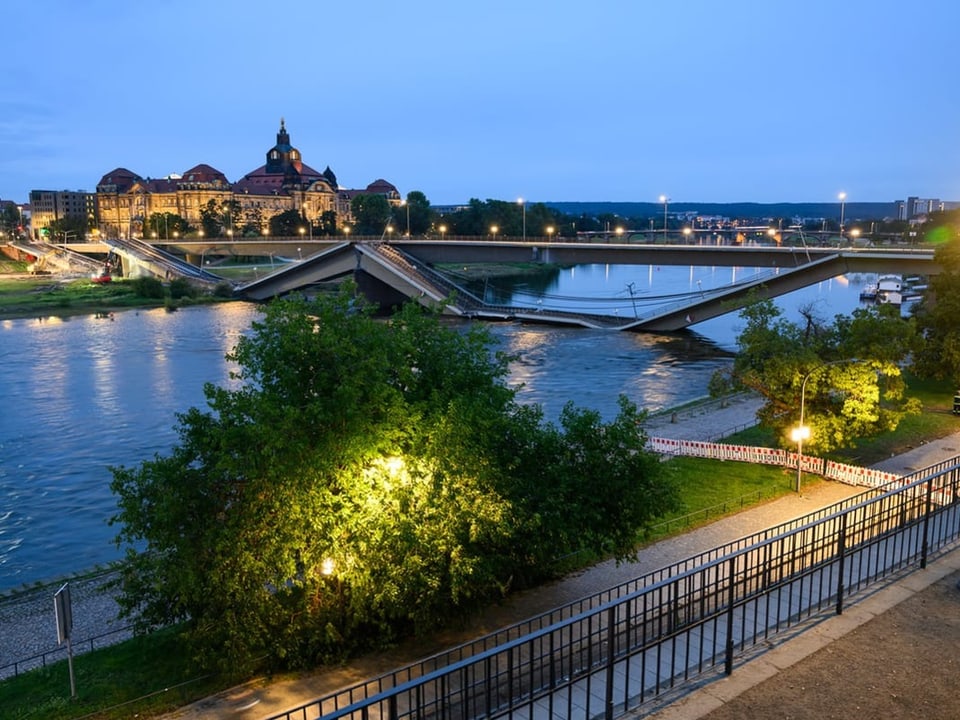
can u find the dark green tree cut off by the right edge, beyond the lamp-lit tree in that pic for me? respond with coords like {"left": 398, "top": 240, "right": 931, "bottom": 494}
{"left": 913, "top": 239, "right": 960, "bottom": 387}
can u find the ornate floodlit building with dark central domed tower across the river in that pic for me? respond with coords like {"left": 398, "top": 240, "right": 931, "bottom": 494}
{"left": 96, "top": 118, "right": 401, "bottom": 239}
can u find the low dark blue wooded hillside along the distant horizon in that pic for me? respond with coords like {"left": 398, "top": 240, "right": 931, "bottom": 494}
{"left": 543, "top": 202, "right": 897, "bottom": 221}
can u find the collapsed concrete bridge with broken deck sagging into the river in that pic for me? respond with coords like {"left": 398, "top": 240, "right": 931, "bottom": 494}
{"left": 236, "top": 240, "right": 939, "bottom": 332}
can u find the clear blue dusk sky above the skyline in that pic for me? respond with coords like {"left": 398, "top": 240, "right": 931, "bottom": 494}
{"left": 0, "top": 0, "right": 960, "bottom": 204}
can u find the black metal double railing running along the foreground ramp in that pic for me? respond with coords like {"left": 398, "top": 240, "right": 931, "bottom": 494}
{"left": 271, "top": 458, "right": 960, "bottom": 720}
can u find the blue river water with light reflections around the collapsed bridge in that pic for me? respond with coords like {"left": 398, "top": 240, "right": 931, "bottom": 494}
{"left": 0, "top": 266, "right": 870, "bottom": 592}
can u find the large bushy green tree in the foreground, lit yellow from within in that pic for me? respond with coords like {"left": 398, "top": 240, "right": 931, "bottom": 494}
{"left": 112, "top": 292, "right": 677, "bottom": 672}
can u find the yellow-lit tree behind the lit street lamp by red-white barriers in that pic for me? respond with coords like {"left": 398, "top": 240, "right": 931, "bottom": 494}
{"left": 711, "top": 300, "right": 920, "bottom": 453}
